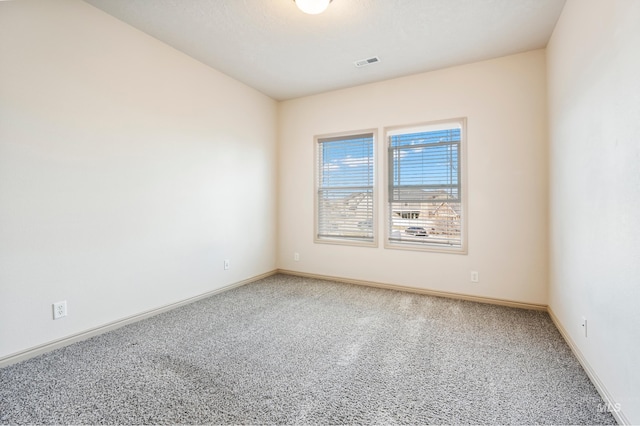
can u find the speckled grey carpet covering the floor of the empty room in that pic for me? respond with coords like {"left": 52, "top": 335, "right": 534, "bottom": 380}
{"left": 0, "top": 275, "right": 615, "bottom": 424}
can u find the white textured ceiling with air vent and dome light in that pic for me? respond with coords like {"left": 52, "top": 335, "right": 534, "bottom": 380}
{"left": 85, "top": 0, "right": 565, "bottom": 100}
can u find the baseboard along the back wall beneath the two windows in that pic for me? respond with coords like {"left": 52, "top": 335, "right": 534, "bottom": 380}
{"left": 278, "top": 269, "right": 547, "bottom": 311}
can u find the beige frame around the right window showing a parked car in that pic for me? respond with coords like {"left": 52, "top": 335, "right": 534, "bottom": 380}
{"left": 384, "top": 117, "right": 469, "bottom": 254}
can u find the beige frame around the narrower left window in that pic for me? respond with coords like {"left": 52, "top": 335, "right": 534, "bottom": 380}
{"left": 313, "top": 129, "right": 379, "bottom": 247}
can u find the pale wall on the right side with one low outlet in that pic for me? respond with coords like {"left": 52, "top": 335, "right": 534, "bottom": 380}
{"left": 547, "top": 0, "right": 640, "bottom": 424}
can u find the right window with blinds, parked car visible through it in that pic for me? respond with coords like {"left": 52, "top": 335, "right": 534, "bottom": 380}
{"left": 387, "top": 119, "right": 465, "bottom": 253}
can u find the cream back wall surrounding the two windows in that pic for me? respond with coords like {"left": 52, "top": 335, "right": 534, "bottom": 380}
{"left": 278, "top": 50, "right": 547, "bottom": 304}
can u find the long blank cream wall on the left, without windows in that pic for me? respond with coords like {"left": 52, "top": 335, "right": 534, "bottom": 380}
{"left": 0, "top": 0, "right": 277, "bottom": 359}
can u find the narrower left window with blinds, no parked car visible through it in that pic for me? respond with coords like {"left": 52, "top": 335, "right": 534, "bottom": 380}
{"left": 316, "top": 132, "right": 375, "bottom": 245}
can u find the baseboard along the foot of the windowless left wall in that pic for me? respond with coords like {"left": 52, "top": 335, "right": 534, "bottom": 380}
{"left": 0, "top": 270, "right": 277, "bottom": 368}
